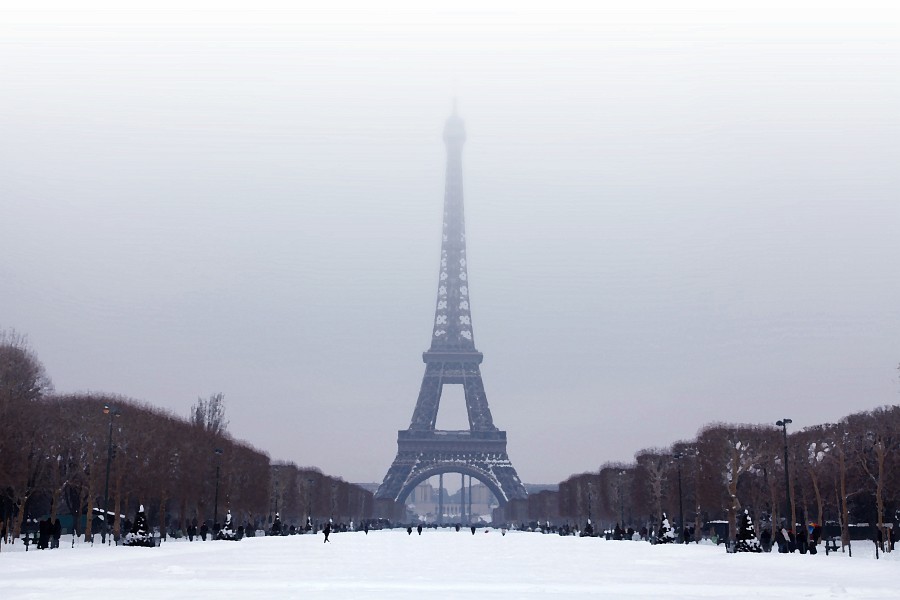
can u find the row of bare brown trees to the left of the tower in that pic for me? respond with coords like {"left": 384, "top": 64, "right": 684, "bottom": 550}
{"left": 0, "top": 331, "right": 372, "bottom": 540}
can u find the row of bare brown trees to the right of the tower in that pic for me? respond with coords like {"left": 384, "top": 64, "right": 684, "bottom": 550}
{"left": 552, "top": 406, "right": 900, "bottom": 545}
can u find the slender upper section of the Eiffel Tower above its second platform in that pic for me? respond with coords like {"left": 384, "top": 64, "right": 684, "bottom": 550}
{"left": 426, "top": 106, "right": 476, "bottom": 360}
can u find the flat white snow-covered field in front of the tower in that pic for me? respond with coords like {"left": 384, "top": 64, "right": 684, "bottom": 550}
{"left": 0, "top": 529, "right": 900, "bottom": 600}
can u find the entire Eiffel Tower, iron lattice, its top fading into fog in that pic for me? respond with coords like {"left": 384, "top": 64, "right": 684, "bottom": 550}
{"left": 375, "top": 104, "right": 527, "bottom": 518}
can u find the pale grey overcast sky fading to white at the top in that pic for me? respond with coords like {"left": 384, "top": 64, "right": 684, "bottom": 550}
{"left": 0, "top": 0, "right": 900, "bottom": 482}
